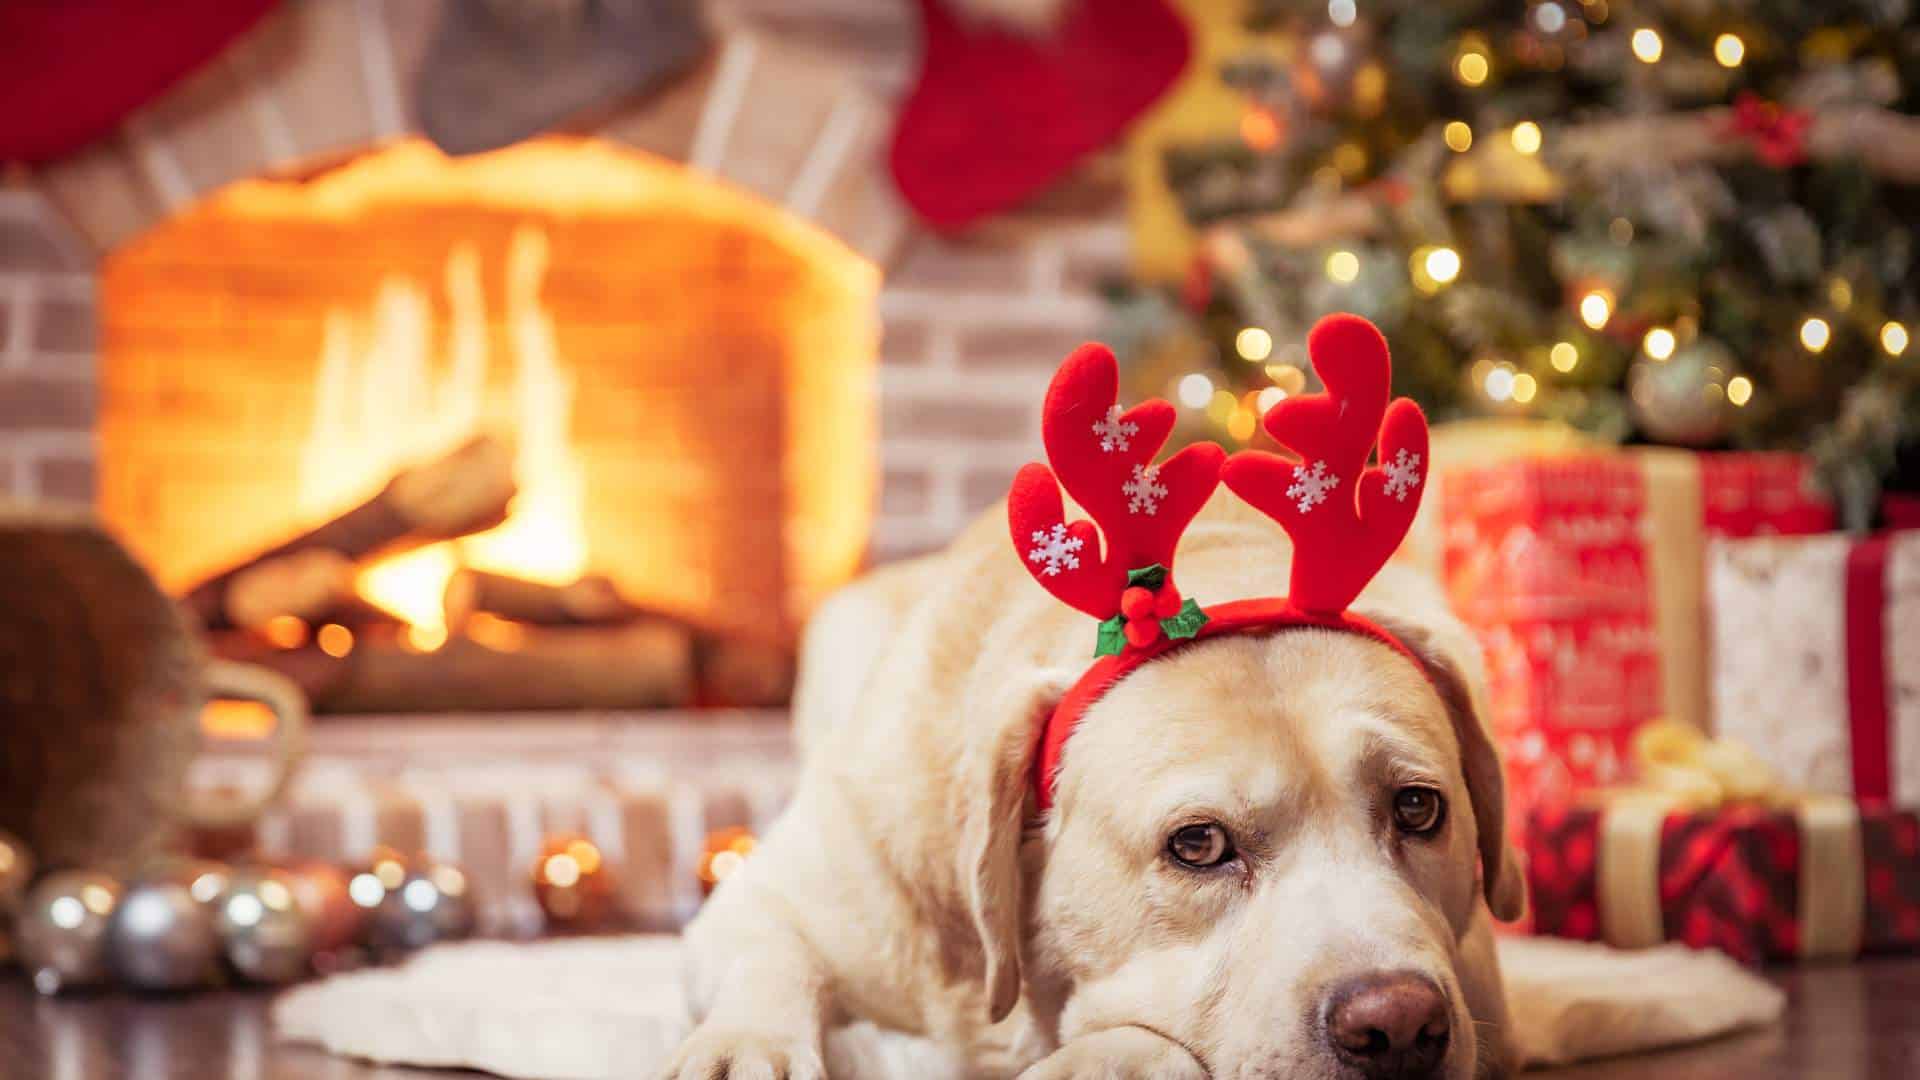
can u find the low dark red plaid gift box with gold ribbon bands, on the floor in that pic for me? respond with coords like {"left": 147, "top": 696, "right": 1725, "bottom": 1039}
{"left": 1524, "top": 798, "right": 1920, "bottom": 963}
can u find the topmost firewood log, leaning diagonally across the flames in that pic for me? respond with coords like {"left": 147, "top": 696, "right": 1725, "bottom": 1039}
{"left": 184, "top": 436, "right": 515, "bottom": 630}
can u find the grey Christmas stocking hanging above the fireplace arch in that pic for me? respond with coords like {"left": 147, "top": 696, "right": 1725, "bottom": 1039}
{"left": 419, "top": 0, "right": 707, "bottom": 154}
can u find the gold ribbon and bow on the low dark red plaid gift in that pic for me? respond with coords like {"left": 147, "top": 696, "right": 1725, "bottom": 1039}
{"left": 1597, "top": 721, "right": 1866, "bottom": 959}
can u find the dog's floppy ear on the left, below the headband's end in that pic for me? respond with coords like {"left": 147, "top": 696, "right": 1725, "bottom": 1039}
{"left": 956, "top": 673, "right": 1071, "bottom": 1022}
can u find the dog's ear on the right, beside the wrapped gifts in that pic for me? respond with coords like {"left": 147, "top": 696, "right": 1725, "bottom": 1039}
{"left": 1369, "top": 615, "right": 1526, "bottom": 922}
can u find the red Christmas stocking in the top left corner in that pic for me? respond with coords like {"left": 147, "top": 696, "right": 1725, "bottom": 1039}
{"left": 0, "top": 0, "right": 275, "bottom": 161}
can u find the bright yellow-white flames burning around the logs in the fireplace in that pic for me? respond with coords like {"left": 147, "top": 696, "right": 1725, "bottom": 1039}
{"left": 300, "top": 227, "right": 588, "bottom": 650}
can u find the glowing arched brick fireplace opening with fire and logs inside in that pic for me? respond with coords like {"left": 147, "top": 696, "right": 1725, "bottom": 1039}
{"left": 98, "top": 138, "right": 879, "bottom": 713}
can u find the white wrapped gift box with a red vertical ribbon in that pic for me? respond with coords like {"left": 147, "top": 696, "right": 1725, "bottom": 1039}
{"left": 1707, "top": 530, "right": 1920, "bottom": 805}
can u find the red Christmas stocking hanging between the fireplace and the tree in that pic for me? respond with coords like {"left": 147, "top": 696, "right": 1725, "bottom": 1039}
{"left": 891, "top": 0, "right": 1188, "bottom": 229}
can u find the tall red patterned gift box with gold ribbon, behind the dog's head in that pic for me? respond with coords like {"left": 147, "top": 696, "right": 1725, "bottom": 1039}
{"left": 1440, "top": 448, "right": 1834, "bottom": 819}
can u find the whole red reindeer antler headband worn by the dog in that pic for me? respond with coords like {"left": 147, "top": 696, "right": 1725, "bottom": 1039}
{"left": 1006, "top": 315, "right": 1427, "bottom": 813}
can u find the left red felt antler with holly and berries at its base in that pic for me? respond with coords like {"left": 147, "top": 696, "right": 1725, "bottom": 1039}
{"left": 1006, "top": 344, "right": 1225, "bottom": 651}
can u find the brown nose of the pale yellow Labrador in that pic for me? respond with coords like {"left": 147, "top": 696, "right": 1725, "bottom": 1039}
{"left": 1327, "top": 972, "right": 1453, "bottom": 1080}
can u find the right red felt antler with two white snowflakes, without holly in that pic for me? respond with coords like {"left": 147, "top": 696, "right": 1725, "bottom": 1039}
{"left": 1221, "top": 315, "right": 1427, "bottom": 615}
